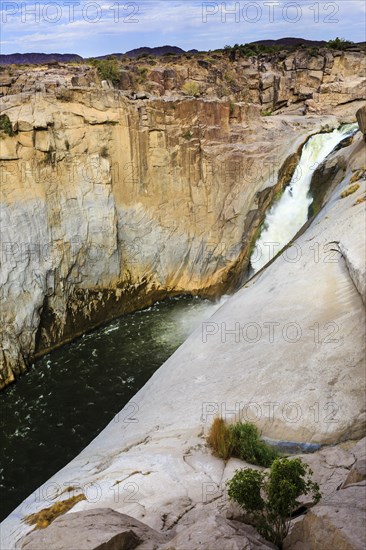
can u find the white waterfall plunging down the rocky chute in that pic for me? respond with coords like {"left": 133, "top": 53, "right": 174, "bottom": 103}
{"left": 250, "top": 124, "right": 358, "bottom": 275}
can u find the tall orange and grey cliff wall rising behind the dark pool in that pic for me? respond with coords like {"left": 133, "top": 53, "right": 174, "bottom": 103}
{"left": 0, "top": 52, "right": 364, "bottom": 387}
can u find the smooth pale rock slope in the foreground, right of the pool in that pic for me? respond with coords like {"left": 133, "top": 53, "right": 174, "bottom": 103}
{"left": 1, "top": 105, "right": 366, "bottom": 550}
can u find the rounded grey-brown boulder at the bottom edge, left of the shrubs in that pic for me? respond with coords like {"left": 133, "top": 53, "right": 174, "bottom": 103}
{"left": 21, "top": 508, "right": 167, "bottom": 550}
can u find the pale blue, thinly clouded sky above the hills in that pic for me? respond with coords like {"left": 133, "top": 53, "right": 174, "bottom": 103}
{"left": 0, "top": 0, "right": 366, "bottom": 57}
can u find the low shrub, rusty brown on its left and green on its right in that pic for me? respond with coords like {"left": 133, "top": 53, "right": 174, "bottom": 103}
{"left": 207, "top": 418, "right": 278, "bottom": 467}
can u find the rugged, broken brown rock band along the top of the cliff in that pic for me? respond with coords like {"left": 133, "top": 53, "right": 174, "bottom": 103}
{"left": 0, "top": 46, "right": 366, "bottom": 113}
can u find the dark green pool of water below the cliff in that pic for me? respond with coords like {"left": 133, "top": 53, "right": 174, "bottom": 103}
{"left": 0, "top": 298, "right": 218, "bottom": 519}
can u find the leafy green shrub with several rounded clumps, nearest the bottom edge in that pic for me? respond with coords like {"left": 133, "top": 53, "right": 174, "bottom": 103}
{"left": 227, "top": 458, "right": 321, "bottom": 548}
